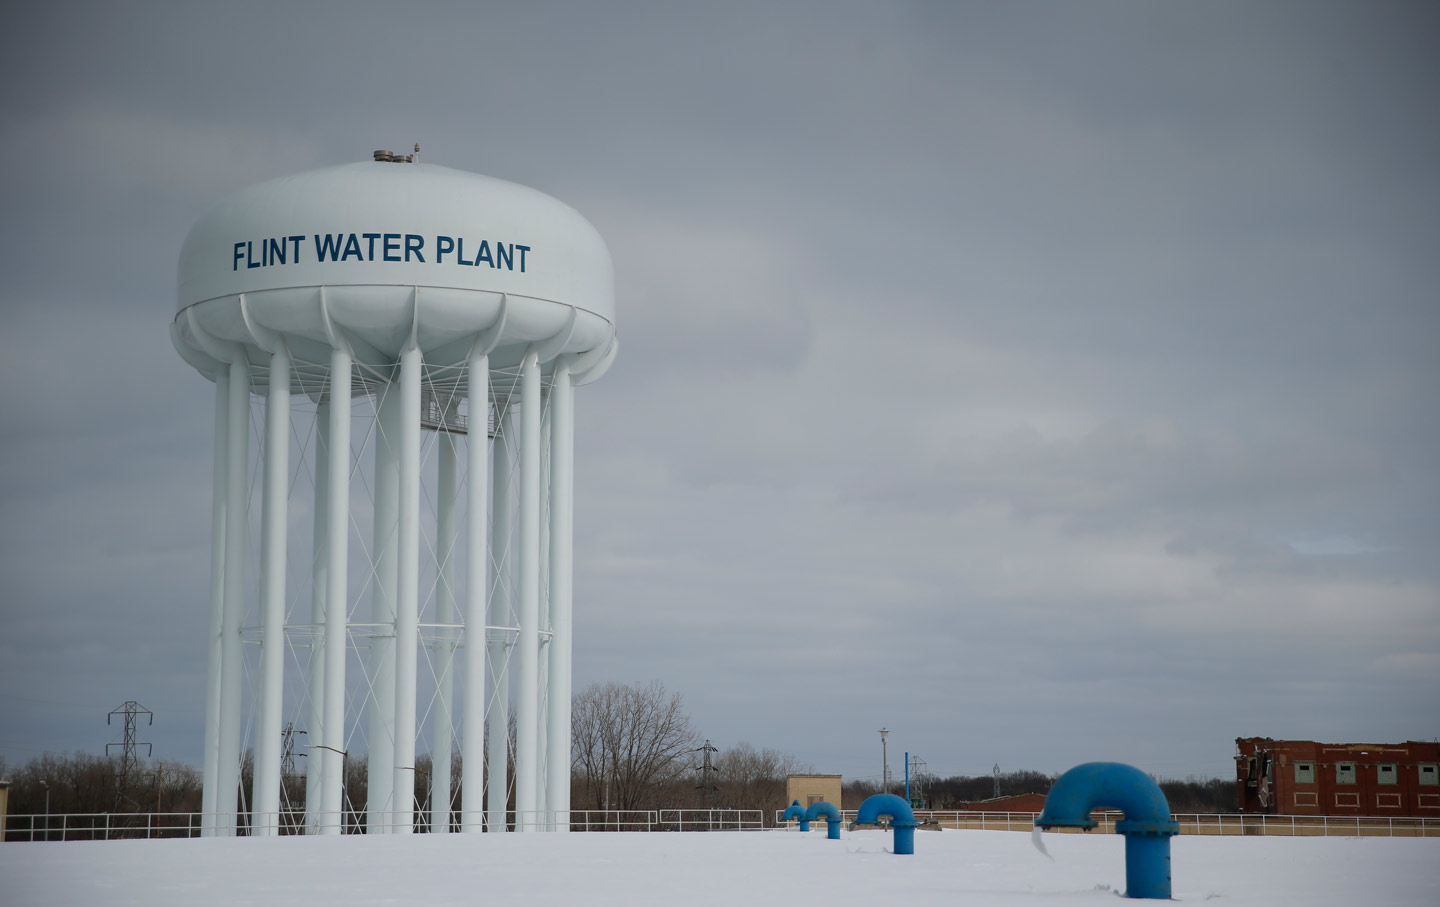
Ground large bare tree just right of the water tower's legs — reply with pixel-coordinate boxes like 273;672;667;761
572;681;700;809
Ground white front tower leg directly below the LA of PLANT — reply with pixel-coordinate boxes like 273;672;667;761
459;351;490;832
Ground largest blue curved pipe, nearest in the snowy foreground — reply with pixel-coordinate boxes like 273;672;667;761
1035;762;1179;900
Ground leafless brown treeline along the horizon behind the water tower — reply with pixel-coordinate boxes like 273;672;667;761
0;682;1236;826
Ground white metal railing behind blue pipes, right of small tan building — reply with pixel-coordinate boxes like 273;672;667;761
775;809;1440;838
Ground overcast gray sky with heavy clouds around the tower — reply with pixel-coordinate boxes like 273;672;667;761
0;1;1440;777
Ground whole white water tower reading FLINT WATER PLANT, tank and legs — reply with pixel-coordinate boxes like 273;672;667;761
170;153;618;835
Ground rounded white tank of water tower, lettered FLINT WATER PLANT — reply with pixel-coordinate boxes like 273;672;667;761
179;161;615;369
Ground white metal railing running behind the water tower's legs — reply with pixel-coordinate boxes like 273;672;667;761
0;809;765;841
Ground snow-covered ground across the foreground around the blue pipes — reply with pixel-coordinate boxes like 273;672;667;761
0;822;1440;907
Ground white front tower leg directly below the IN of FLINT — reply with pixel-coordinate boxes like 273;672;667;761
251;344;289;836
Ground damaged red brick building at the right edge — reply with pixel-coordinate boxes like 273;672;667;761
1236;737;1440;818
